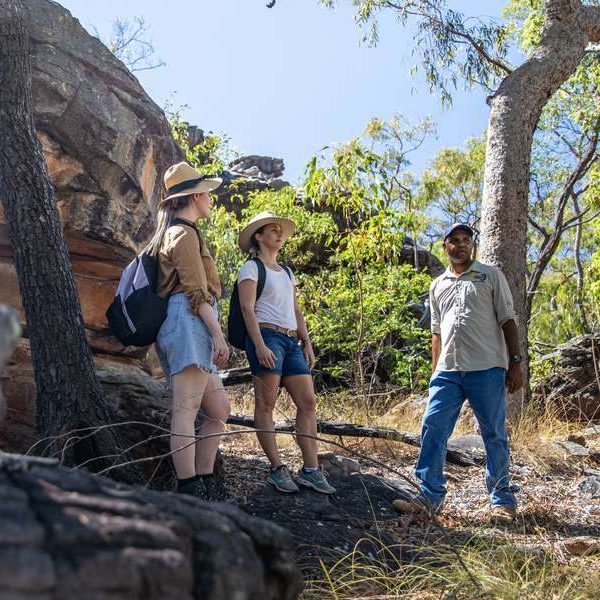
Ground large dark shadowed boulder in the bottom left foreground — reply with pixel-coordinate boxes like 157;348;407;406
0;452;302;600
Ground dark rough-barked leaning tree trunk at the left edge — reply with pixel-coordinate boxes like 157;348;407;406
0;0;138;478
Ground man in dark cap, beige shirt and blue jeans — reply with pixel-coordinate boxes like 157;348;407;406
394;223;523;523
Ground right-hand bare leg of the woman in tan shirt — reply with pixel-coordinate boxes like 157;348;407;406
196;375;229;475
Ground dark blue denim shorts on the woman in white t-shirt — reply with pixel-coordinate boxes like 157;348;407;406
246;328;310;377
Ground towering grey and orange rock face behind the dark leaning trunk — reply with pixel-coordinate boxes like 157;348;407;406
0;0;180;356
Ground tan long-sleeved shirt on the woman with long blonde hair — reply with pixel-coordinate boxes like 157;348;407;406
157;223;221;315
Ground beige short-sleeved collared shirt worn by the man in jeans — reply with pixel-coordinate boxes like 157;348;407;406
429;261;516;371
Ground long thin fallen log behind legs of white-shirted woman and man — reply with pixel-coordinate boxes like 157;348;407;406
227;414;485;467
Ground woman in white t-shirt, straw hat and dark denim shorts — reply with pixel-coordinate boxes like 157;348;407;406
238;211;336;494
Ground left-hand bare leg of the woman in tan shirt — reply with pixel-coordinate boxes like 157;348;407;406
171;365;209;479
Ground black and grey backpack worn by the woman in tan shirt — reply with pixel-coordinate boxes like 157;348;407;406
106;219;202;346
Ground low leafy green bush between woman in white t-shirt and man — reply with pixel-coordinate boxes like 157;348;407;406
301;263;431;389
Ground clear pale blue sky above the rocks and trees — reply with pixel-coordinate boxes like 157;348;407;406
60;0;504;182
